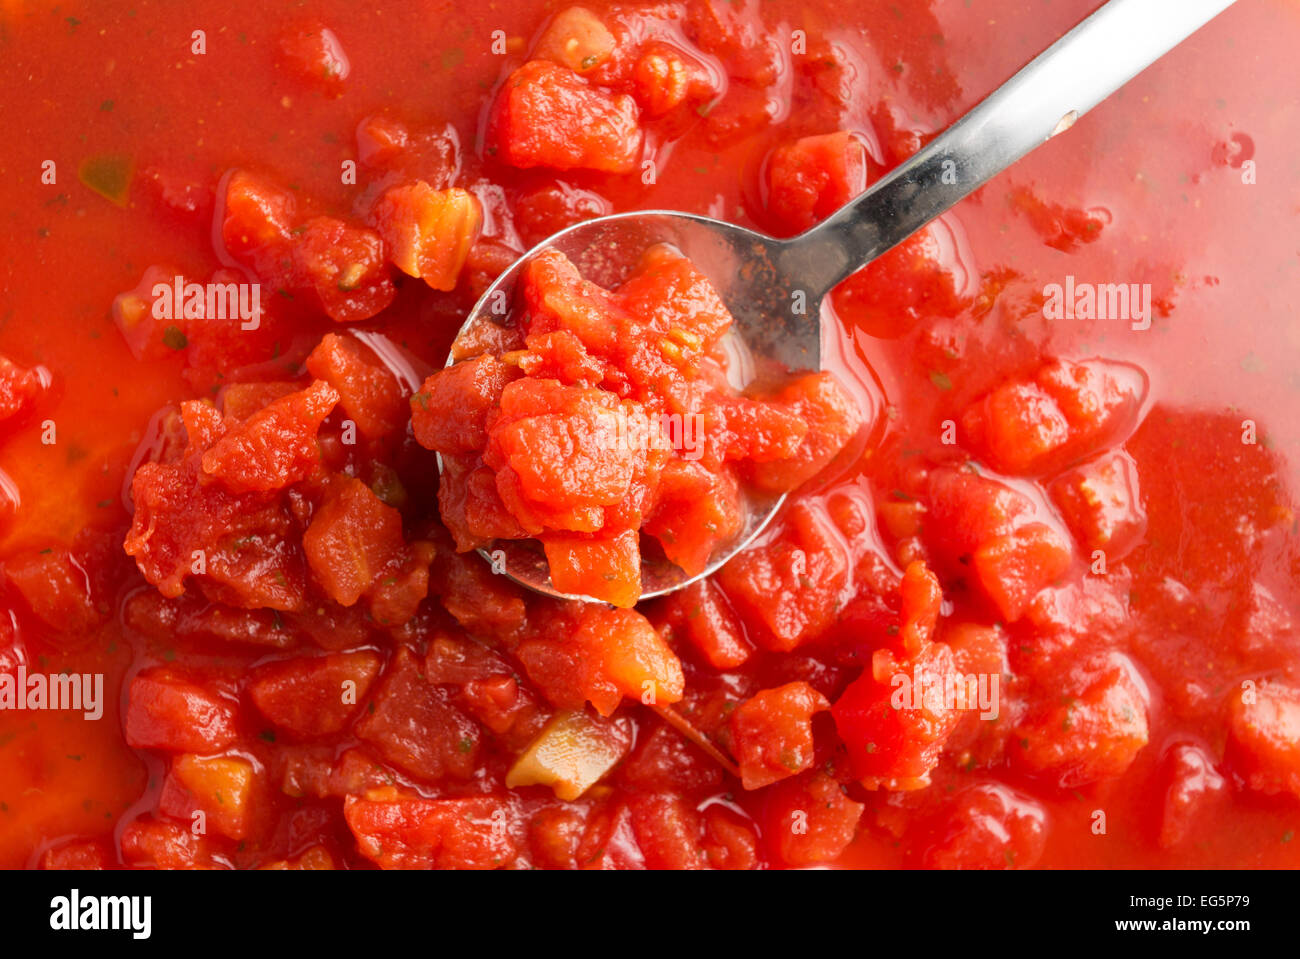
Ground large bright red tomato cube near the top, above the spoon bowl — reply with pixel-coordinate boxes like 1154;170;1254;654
489;60;641;173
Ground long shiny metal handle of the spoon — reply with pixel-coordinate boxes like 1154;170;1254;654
779;0;1235;301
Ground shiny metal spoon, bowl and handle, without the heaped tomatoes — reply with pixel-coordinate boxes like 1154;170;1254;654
439;0;1235;602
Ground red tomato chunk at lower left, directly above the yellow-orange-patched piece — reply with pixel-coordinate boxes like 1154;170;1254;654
125;669;238;754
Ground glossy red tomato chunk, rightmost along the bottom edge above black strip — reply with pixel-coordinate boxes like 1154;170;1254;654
922;782;1048;869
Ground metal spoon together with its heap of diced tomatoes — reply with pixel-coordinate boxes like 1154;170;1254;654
413;0;1234;607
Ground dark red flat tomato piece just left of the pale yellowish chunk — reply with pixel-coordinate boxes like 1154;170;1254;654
356;647;481;782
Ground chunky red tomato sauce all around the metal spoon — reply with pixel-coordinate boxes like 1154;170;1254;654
0;0;1300;868
